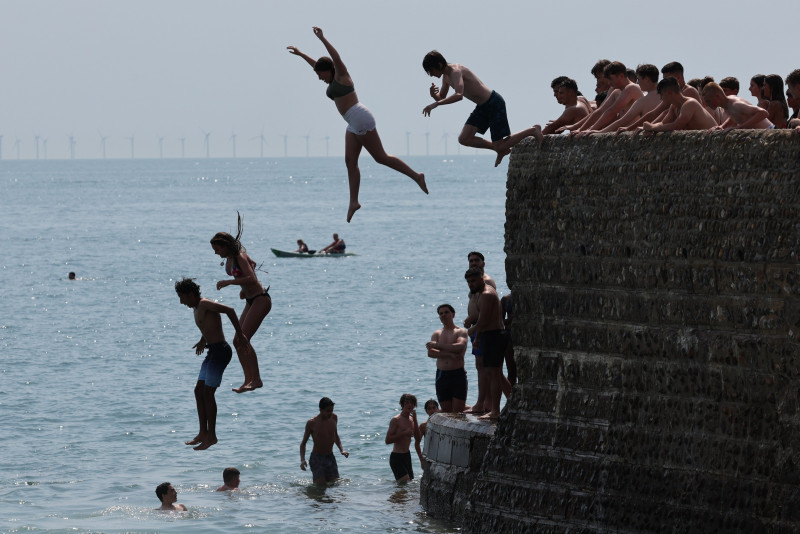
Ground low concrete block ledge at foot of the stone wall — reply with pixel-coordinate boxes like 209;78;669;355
420;413;495;523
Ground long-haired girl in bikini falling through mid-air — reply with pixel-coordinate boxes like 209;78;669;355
211;214;272;393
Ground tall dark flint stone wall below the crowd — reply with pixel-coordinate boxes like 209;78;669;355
464;131;800;533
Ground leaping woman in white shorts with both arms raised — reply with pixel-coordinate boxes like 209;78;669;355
286;26;428;222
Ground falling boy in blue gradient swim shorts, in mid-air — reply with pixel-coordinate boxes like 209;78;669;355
175;278;251;451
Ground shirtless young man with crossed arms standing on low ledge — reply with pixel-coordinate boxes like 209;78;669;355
425;304;467;412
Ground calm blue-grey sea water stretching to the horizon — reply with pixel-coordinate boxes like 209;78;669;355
0;156;507;533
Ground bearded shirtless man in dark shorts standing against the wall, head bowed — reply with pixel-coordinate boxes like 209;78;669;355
464;269;508;419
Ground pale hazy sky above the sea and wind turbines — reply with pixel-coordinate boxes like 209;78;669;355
0;0;800;160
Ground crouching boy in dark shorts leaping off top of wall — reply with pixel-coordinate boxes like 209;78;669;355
422;50;533;167
